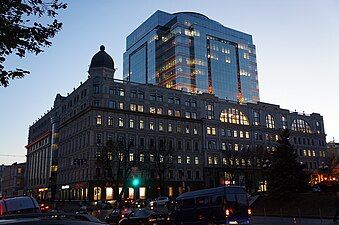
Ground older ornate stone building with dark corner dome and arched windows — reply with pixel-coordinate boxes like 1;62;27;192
27;46;326;201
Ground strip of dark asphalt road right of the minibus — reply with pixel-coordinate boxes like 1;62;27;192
251;216;339;225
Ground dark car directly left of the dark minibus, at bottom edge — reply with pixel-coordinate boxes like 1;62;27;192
119;209;171;225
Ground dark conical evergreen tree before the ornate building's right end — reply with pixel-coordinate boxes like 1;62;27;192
267;129;309;198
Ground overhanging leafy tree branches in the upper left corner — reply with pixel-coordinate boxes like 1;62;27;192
0;0;67;87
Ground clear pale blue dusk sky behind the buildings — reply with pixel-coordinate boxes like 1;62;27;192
0;0;339;164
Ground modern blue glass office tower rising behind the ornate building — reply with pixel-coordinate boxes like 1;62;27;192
123;11;259;102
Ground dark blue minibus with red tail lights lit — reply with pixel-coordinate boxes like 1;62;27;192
174;186;252;224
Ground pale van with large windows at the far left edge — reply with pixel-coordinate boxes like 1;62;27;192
0;196;40;216
